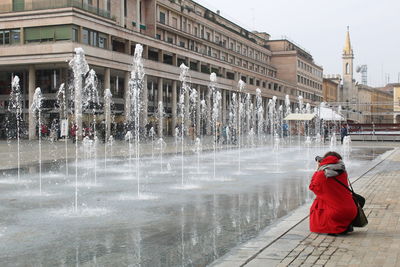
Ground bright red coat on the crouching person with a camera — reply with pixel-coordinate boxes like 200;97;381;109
309;156;357;234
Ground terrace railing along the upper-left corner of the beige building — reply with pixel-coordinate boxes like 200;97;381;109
0;0;115;20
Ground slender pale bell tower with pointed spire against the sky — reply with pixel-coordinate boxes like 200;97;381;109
340;26;357;103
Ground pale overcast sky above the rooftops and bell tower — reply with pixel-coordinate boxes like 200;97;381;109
195;0;400;86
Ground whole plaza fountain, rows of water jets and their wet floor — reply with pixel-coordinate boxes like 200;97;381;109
0;40;394;266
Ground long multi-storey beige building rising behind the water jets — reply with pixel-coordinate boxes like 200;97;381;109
0;0;322;138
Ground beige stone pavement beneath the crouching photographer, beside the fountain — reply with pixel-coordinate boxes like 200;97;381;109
212;143;400;267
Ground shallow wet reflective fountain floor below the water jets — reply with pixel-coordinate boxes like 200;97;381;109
0;148;388;266
